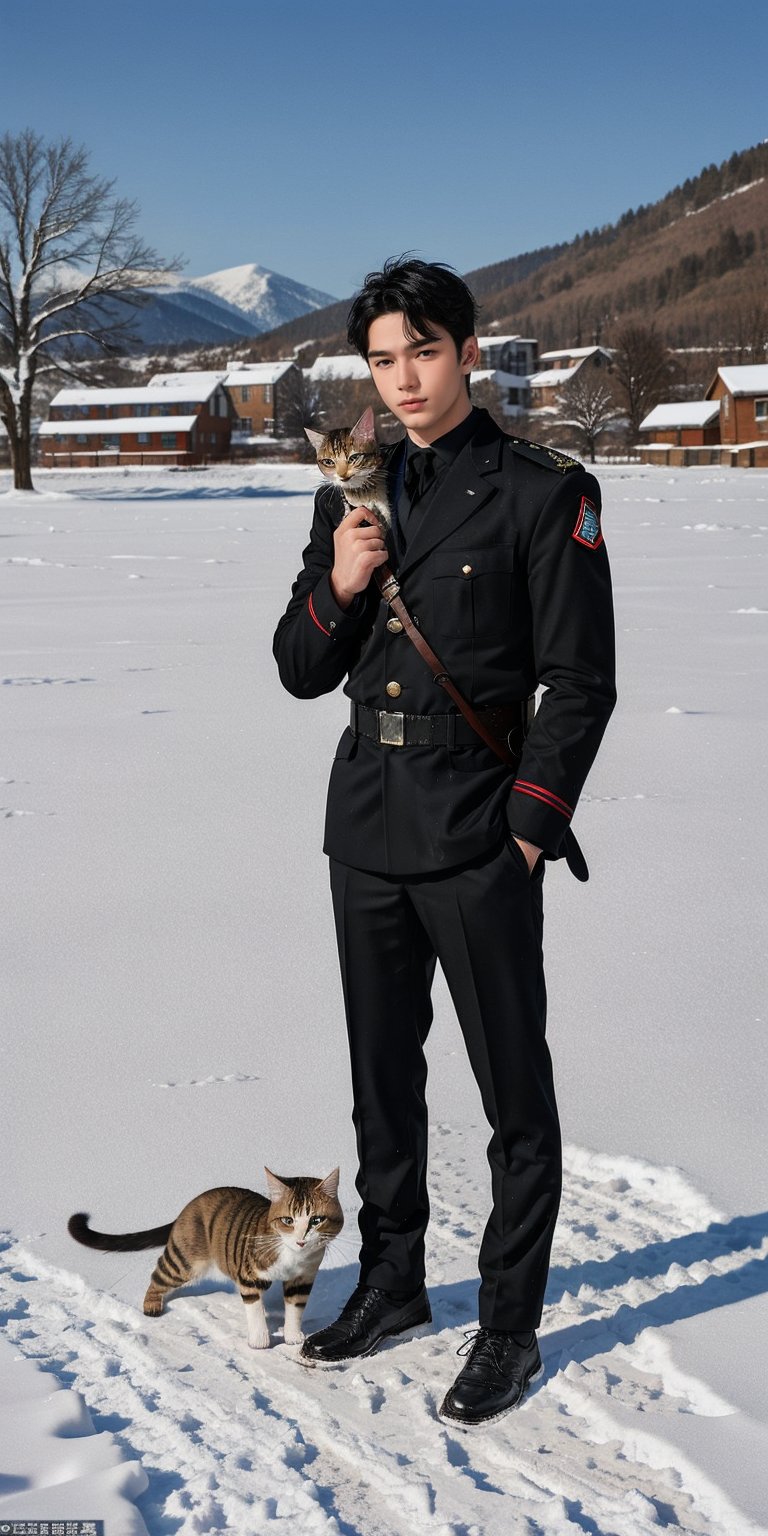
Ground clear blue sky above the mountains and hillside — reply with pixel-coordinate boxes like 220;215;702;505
0;0;768;296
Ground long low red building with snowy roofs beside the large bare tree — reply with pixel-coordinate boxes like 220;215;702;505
40;373;232;468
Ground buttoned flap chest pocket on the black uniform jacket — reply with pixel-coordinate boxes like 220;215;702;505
432;544;515;641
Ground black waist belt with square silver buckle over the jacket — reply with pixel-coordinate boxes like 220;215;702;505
349;694;536;751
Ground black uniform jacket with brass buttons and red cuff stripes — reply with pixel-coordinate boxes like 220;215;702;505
273;412;616;876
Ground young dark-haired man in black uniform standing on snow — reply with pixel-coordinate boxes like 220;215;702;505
275;260;616;1424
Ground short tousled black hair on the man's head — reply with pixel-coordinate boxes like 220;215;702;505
347;253;478;358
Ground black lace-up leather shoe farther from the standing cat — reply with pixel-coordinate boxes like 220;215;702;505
439;1329;544;1428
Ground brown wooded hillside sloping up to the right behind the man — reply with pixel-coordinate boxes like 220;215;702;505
255;141;768;356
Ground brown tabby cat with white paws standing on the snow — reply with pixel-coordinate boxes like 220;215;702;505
68;1167;344;1349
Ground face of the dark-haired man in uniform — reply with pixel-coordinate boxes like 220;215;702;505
369;310;478;445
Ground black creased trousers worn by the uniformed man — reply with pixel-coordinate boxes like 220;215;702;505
330;837;562;1330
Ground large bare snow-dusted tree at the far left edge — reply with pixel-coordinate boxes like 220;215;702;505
0;129;180;490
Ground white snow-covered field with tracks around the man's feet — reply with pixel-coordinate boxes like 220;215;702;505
0;465;768;1536
